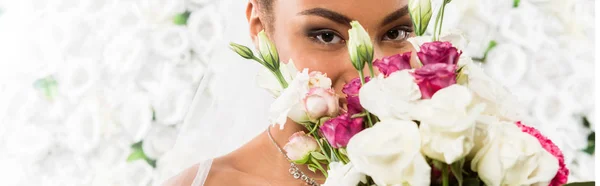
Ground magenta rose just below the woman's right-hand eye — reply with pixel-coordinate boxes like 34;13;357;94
373;52;411;77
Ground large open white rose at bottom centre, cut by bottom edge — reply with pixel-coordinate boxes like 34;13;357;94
347;119;431;186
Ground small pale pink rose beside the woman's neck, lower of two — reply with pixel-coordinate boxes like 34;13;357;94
283;131;319;164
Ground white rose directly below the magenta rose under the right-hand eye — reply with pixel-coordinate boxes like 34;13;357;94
359;70;421;120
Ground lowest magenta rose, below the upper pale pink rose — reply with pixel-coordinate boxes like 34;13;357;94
320;113;364;148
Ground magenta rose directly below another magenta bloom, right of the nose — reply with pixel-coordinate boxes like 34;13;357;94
412;63;457;99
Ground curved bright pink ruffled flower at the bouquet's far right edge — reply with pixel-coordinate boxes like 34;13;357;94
516;121;569;186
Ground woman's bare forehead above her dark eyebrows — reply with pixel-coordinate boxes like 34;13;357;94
276;0;408;26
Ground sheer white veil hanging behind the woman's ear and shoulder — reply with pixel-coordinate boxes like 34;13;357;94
158;0;273;180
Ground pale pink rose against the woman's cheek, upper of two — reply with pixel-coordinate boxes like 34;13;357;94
303;87;339;121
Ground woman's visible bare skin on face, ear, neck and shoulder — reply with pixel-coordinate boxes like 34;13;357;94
165;0;415;186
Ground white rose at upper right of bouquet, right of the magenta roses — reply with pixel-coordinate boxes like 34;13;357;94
459;61;523;121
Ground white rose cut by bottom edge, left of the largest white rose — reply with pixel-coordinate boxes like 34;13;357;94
323;162;367;186
